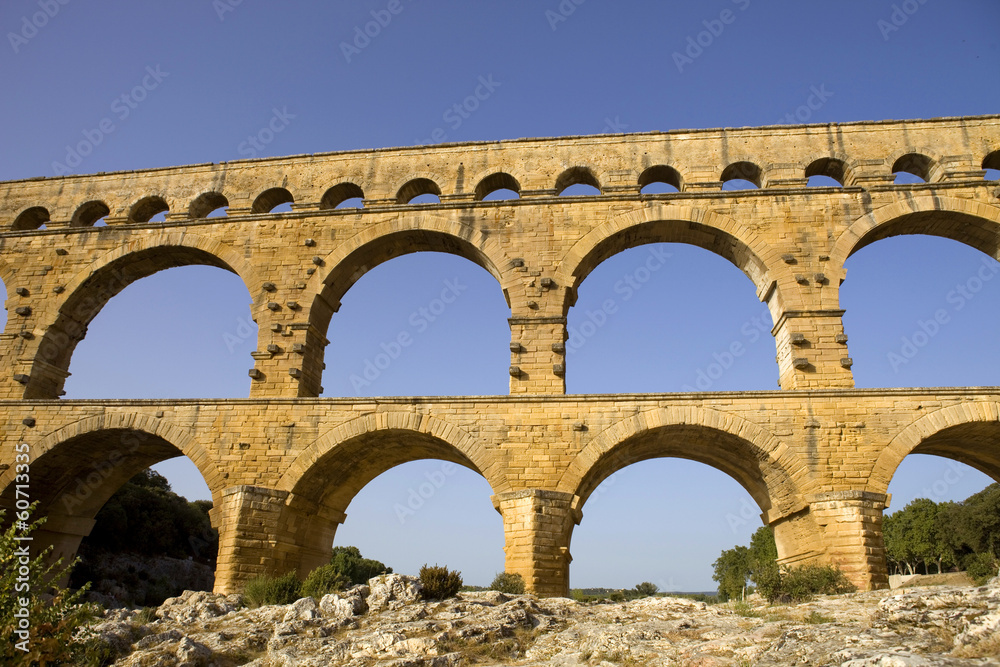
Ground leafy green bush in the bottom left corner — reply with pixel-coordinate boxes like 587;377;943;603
0;505;95;665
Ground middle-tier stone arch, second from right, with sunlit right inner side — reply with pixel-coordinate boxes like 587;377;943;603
556;202;796;316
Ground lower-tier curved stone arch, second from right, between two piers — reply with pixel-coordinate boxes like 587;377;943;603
557;406;807;521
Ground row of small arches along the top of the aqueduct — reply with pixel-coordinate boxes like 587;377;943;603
0;150;1000;231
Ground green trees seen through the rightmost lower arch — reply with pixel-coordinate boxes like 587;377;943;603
882;484;1000;584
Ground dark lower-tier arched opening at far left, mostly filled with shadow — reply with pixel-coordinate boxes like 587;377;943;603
2;428;218;606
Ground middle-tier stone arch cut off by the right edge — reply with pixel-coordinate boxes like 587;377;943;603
830;196;1000;267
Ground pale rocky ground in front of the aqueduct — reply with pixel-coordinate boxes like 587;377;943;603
86;575;1000;667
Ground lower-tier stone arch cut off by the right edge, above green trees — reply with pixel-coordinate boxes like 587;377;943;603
866;401;1000;494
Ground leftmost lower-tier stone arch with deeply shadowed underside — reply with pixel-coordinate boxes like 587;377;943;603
0;410;225;576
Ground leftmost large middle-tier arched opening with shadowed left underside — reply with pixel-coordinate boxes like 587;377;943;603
25;246;256;398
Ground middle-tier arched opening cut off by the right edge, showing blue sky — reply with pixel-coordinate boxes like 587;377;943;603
840;236;1000;387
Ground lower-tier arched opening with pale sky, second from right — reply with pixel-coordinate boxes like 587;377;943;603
570;424;796;592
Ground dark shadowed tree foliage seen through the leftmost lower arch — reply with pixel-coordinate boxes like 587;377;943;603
81;469;219;565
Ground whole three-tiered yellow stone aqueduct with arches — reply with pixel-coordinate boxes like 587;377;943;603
0;116;1000;595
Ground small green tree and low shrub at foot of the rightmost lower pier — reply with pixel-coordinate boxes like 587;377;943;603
712;526;855;602
